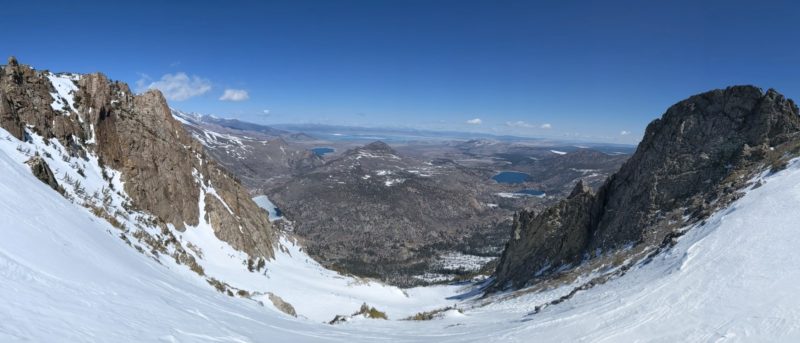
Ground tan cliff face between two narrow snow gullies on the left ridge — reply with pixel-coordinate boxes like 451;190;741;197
78;74;206;229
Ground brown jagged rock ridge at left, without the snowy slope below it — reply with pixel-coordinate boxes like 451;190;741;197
0;59;274;257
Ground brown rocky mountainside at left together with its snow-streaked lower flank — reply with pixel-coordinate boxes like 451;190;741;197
0;58;275;259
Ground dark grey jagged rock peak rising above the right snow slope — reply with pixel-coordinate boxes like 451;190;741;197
494;86;800;289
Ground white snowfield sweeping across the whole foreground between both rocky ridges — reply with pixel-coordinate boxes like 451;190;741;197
0;118;800;342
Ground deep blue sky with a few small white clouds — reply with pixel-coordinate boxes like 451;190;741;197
0;0;800;143
